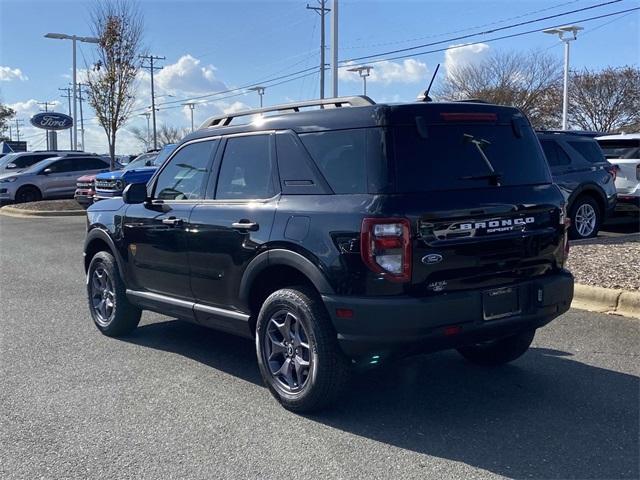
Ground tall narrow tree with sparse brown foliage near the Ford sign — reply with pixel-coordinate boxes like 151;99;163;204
87;0;143;169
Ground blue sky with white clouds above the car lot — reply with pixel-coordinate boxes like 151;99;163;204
0;0;640;153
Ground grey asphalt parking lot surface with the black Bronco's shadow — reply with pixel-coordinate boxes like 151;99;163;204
0;217;640;479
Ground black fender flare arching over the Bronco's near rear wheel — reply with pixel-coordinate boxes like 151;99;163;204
239;248;335;304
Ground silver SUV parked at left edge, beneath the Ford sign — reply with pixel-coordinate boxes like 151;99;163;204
0;155;109;203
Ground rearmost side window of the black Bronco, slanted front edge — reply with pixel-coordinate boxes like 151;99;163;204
300;129;368;193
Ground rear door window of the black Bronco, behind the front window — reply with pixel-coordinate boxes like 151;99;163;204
216;135;275;199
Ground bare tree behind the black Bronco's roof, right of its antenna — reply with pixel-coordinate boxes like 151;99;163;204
437;51;562;128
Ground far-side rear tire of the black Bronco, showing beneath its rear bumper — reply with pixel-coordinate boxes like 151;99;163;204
458;330;536;367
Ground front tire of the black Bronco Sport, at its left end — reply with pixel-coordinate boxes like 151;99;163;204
87;252;142;337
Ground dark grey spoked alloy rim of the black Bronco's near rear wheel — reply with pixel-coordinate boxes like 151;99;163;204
263;310;312;393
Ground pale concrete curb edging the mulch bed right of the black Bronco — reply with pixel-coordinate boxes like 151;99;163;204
571;283;640;319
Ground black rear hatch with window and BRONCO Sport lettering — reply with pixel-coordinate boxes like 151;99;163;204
364;104;566;296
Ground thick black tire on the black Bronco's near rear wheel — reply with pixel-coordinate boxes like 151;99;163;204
256;286;351;413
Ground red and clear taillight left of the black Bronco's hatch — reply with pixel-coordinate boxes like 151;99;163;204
360;218;411;282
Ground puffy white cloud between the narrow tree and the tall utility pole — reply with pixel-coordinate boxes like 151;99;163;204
154;55;226;95
